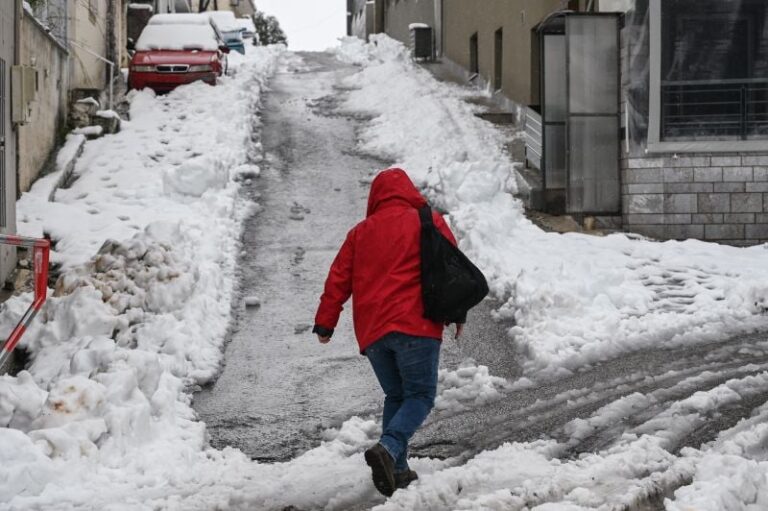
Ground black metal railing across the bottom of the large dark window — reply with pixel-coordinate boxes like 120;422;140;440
661;79;768;140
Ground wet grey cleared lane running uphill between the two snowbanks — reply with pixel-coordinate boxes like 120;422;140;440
195;53;517;461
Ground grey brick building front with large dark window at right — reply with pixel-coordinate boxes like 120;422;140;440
622;0;768;245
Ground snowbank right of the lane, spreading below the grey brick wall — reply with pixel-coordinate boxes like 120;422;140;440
337;35;768;379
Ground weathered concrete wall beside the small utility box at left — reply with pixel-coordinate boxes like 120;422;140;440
18;11;69;192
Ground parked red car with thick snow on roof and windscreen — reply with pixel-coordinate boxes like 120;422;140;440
128;14;229;92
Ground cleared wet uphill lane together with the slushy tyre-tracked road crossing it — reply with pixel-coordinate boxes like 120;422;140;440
195;49;768;509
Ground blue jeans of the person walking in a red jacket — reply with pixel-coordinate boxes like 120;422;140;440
365;333;440;472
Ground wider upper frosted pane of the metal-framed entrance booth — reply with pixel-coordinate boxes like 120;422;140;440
566;16;619;114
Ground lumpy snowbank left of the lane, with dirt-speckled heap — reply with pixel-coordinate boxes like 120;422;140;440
0;46;283;509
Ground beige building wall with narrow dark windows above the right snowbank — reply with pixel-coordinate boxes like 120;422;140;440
442;0;563;105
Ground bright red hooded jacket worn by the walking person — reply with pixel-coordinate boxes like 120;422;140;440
315;168;456;353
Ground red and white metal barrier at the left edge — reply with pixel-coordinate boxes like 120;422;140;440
0;234;51;366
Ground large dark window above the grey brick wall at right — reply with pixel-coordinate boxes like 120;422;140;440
660;0;768;142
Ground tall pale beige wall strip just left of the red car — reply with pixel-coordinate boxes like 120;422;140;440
69;0;109;90
